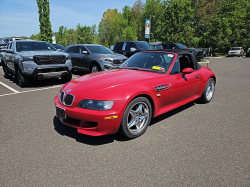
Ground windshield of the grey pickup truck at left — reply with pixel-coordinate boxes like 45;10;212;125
16;42;55;52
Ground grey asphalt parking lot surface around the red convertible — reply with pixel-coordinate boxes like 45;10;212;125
0;57;250;187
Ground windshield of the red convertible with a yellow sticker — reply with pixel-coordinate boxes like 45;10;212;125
120;52;175;73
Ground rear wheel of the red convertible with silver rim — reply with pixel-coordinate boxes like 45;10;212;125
200;78;215;103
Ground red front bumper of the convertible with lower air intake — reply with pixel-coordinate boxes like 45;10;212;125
55;94;126;136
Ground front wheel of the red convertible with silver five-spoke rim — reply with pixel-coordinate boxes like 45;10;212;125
119;97;152;139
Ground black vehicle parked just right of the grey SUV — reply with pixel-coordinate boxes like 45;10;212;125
113;41;154;57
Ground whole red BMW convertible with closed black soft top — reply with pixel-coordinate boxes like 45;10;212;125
55;49;216;138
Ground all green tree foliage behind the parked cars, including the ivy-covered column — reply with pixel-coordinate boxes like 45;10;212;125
30;0;250;53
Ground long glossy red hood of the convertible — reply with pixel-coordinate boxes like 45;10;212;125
62;69;163;102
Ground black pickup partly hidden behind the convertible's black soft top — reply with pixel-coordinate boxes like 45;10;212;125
158;42;204;61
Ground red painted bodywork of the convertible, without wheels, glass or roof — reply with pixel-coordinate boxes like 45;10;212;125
55;51;215;136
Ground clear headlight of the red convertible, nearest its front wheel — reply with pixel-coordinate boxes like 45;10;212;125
77;99;114;110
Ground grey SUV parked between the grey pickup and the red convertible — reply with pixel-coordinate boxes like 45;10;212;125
64;44;127;73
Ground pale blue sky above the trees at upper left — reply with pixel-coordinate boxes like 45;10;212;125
0;0;144;38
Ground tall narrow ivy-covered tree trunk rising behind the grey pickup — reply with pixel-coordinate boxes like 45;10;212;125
36;0;52;43
